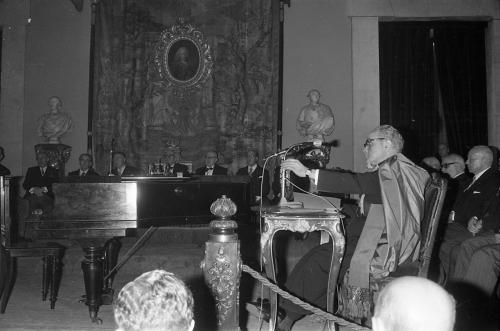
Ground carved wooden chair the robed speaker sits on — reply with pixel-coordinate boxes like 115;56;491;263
339;177;448;324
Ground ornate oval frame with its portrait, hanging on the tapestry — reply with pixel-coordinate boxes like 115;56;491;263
155;19;213;94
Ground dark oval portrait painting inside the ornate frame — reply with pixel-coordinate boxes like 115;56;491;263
167;39;200;81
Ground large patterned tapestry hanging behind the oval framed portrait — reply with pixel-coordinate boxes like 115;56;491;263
92;0;279;173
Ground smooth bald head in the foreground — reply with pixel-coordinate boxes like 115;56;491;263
372;276;455;331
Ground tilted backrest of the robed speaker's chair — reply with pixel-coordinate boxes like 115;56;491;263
418;176;448;278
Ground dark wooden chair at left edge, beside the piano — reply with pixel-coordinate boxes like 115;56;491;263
0;176;65;314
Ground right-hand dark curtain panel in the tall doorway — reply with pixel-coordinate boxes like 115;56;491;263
435;22;488;155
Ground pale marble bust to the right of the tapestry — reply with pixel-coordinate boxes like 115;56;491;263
296;90;335;141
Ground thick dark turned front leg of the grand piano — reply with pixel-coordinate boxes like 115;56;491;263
82;243;104;324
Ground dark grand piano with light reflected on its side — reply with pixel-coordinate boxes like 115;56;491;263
25;176;251;323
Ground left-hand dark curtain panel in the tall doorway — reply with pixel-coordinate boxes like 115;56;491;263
379;22;439;162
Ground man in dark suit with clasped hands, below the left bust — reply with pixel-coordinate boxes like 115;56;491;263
23;152;59;213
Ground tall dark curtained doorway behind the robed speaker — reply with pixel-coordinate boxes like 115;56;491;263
379;21;488;161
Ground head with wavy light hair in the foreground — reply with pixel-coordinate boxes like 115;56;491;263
113;270;194;331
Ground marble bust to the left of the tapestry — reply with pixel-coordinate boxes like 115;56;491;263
38;96;72;144
